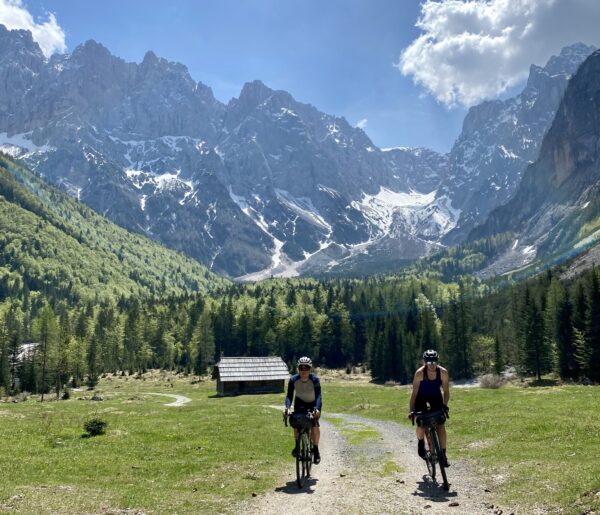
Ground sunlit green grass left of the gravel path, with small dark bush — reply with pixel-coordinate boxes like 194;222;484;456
0;377;292;513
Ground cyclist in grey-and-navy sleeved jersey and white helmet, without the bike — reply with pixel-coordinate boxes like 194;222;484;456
283;356;322;465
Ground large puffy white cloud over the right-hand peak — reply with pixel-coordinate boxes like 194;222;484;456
397;0;600;106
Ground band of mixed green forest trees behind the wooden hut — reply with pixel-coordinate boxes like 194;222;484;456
0;260;600;396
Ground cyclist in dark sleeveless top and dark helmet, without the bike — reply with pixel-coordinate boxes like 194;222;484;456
408;349;450;467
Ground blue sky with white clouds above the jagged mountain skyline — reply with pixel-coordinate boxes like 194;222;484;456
0;0;600;152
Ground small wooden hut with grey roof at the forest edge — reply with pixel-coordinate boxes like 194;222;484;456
212;356;290;395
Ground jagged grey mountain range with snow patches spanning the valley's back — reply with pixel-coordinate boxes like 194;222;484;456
0;26;594;279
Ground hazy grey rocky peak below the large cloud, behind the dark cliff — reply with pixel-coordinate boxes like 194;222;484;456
442;44;594;243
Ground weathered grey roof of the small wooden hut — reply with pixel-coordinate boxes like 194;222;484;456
213;356;290;382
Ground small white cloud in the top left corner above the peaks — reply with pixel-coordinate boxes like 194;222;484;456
0;0;66;57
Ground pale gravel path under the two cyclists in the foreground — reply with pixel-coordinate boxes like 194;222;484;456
241;414;512;515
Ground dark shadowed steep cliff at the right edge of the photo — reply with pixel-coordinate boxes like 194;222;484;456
469;51;600;278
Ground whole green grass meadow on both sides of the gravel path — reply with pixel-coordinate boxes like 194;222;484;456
0;372;600;514
